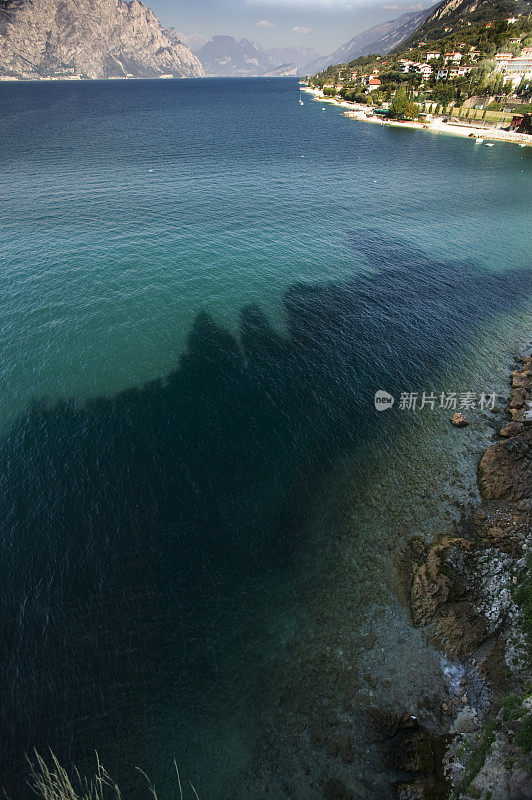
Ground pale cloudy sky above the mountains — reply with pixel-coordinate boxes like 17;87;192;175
148;0;435;55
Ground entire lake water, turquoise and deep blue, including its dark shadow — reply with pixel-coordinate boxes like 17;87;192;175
0;79;532;800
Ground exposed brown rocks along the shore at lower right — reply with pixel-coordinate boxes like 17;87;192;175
386;356;532;800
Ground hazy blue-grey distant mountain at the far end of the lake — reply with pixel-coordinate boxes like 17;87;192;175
196;36;308;78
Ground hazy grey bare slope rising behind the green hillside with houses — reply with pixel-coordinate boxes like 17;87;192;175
305;0;438;74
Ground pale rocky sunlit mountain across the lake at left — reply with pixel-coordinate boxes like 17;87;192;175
0;0;204;79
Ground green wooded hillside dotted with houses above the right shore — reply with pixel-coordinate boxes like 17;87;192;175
310;0;532;95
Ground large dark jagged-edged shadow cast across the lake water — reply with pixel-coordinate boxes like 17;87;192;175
0;231;526;800
